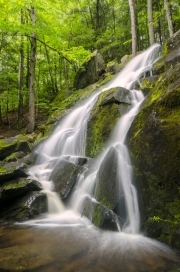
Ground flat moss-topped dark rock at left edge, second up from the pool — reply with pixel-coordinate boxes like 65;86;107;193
0;179;42;203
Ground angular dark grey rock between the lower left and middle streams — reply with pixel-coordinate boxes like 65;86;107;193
49;159;82;199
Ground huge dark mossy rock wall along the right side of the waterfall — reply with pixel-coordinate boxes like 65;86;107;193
127;60;180;250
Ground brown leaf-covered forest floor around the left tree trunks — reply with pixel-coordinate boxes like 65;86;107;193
0;108;47;138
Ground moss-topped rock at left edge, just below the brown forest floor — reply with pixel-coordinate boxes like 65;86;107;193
0;135;31;160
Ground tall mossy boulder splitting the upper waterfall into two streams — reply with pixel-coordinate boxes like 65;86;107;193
86;87;128;157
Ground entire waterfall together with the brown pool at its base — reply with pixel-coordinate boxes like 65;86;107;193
0;45;180;272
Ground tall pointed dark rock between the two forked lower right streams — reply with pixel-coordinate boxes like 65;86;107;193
95;147;122;210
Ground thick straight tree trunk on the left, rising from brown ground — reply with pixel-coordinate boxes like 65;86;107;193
27;7;36;133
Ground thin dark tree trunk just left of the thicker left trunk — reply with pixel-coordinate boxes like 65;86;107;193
18;9;24;128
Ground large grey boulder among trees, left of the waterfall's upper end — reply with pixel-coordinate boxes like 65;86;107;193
74;51;105;89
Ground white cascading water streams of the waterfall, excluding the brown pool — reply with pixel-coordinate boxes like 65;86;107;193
29;45;159;233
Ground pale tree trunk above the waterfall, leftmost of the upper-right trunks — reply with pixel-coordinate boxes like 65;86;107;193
128;0;137;57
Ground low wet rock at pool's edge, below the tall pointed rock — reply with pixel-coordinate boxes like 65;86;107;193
82;198;119;231
